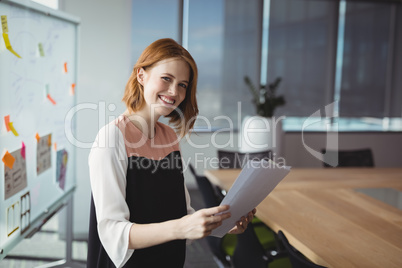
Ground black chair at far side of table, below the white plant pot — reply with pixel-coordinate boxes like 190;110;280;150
218;150;272;169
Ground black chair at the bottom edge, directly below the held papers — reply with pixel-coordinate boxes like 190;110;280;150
233;223;291;268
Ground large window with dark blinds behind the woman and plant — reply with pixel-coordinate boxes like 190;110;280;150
133;0;402;130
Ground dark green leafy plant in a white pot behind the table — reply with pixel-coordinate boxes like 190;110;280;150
239;76;286;154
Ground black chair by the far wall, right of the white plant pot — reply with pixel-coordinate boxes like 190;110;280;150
321;149;374;167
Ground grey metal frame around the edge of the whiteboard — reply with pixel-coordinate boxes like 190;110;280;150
0;0;81;261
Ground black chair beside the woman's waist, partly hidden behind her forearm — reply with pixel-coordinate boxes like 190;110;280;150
189;164;237;267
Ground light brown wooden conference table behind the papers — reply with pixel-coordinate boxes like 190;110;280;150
205;168;402;268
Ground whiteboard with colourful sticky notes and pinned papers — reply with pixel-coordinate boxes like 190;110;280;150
0;0;79;260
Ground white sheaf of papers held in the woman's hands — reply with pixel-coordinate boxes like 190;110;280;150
211;160;290;237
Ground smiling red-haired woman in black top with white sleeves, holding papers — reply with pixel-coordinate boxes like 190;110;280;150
87;39;255;268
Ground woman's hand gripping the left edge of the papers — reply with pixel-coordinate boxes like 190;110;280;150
176;205;230;239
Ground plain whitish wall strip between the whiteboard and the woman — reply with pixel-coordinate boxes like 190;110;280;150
60;0;132;239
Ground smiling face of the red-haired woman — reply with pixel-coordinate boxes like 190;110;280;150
137;58;190;116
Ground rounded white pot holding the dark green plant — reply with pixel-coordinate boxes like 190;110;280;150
239;115;283;156
